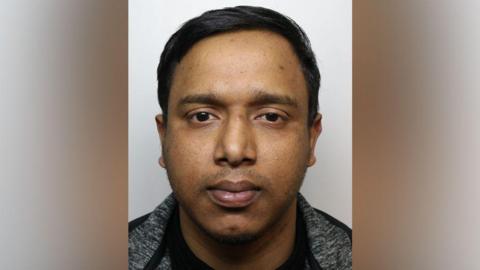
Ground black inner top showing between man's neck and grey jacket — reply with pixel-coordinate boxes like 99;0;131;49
165;207;308;270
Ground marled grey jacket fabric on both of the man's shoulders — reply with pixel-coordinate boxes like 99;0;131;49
128;193;352;270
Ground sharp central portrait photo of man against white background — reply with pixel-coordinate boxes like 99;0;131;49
128;1;352;269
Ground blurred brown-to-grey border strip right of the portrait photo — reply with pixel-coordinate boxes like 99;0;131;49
353;1;480;270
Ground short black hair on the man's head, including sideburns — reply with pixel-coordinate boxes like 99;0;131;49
157;6;320;125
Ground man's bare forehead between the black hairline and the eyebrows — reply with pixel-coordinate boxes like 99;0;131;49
170;30;308;105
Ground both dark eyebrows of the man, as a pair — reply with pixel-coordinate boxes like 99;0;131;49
178;90;298;108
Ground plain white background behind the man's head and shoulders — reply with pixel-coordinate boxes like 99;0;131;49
128;0;352;226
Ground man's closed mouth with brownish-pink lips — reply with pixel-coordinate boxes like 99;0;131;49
207;180;261;209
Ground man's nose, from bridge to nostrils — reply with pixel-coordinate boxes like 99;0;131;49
215;116;257;167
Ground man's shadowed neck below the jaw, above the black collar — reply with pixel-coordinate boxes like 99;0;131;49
180;199;297;269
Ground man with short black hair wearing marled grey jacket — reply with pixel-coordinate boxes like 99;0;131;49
129;6;351;269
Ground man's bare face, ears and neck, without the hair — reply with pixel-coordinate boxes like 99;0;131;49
156;30;321;269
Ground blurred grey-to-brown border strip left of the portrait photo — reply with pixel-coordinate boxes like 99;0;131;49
0;0;128;269
